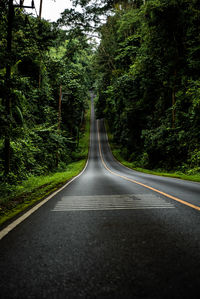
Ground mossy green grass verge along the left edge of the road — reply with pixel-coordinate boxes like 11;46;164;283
0;103;90;226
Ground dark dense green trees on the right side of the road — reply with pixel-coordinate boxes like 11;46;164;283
95;0;200;172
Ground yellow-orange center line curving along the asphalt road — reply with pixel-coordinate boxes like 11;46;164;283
97;121;200;211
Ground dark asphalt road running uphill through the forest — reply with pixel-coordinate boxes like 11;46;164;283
0;98;200;299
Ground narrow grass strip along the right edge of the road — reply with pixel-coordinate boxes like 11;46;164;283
105;122;200;182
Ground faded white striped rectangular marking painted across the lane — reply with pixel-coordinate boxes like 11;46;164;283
52;194;174;212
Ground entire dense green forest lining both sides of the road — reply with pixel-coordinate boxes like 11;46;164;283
0;0;200;218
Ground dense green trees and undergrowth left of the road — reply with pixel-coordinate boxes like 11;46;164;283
0;0;92;188
